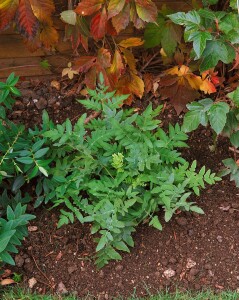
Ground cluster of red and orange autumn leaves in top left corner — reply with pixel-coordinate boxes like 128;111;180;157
0;0;58;51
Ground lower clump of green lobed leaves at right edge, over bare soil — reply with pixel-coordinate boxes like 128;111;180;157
183;88;239;187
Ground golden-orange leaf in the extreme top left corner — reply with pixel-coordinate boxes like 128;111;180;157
0;0;19;30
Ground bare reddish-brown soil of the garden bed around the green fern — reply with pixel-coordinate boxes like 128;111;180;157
6;81;239;299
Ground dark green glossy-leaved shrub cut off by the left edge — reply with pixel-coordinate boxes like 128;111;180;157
0;73;38;264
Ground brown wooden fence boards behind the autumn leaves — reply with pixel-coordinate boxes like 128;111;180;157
0;0;189;78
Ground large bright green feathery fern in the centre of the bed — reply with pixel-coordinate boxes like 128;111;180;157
35;76;220;267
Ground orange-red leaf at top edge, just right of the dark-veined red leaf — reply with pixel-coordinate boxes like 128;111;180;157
29;0;55;22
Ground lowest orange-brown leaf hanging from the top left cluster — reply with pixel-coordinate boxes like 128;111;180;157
40;23;58;50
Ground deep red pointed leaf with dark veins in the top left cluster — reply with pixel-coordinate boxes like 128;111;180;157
16;0;39;38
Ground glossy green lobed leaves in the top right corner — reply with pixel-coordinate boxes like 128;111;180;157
168;1;239;72
